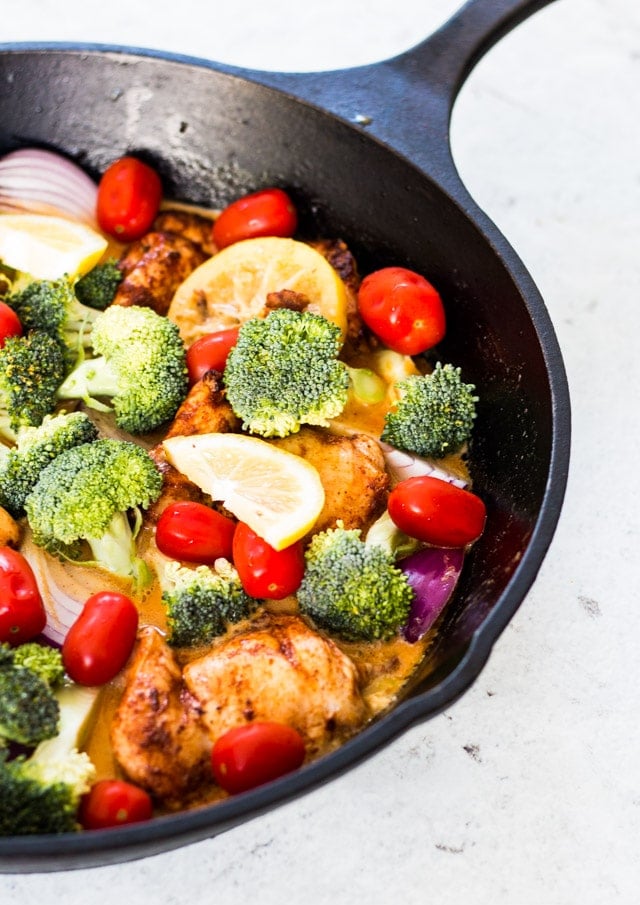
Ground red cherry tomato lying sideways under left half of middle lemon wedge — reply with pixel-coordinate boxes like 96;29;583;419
156;500;236;565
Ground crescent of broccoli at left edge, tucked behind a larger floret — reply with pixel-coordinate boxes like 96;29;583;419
0;412;98;518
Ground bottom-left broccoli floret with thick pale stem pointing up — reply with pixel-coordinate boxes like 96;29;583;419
0;685;96;836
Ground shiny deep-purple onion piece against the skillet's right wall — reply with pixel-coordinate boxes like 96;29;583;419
398;547;464;644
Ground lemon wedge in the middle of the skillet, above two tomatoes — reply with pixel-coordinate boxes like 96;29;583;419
162;434;324;550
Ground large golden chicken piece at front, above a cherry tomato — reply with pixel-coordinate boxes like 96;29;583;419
183;614;367;755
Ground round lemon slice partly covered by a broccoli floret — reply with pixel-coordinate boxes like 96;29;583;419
168;236;347;345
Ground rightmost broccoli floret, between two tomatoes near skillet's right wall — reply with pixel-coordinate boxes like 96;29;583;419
381;362;478;459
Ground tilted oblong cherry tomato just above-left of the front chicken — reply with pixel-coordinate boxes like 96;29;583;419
62;591;138;685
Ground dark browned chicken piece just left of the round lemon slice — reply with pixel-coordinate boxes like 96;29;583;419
113;232;207;314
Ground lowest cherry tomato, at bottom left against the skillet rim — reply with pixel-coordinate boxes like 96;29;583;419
79;779;153;830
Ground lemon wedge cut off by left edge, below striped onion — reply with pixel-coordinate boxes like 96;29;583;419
0;214;108;280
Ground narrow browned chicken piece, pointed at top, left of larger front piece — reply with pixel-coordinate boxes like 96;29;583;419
111;626;211;810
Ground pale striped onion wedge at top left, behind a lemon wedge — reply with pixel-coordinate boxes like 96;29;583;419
0;148;98;229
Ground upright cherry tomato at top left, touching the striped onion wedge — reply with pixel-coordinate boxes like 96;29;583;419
97;157;162;242
